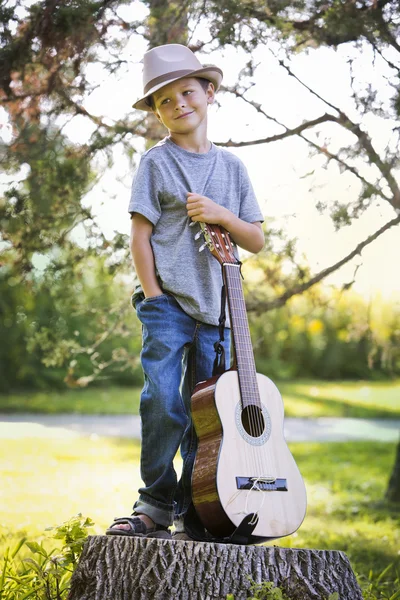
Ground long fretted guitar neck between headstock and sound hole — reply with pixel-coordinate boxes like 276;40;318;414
222;263;261;408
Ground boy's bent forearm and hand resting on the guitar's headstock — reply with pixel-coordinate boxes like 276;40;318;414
186;192;265;254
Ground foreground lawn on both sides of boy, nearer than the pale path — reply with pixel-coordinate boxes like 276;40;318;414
0;433;400;598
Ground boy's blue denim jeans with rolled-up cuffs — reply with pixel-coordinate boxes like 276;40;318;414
133;294;230;526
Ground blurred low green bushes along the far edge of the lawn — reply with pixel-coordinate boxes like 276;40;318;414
0;255;400;391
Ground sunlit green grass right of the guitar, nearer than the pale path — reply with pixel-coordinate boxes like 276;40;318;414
279;442;400;576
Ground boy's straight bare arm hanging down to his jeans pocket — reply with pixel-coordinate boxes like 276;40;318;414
130;213;163;298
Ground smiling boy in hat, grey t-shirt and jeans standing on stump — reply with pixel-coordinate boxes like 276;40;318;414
107;44;264;539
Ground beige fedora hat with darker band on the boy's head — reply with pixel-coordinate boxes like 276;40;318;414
132;44;223;111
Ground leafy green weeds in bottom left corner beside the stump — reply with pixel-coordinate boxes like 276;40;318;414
0;514;94;600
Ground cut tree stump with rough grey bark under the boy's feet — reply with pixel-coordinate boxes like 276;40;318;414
69;536;362;600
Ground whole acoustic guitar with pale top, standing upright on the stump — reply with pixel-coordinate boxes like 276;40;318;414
192;223;307;543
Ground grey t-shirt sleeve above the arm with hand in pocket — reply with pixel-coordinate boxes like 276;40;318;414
128;156;163;225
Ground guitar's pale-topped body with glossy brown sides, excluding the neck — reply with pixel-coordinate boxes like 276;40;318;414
192;371;307;542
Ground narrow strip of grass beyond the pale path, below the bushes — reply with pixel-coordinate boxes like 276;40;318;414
0;380;400;419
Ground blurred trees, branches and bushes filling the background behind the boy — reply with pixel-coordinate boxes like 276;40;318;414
0;0;400;392
